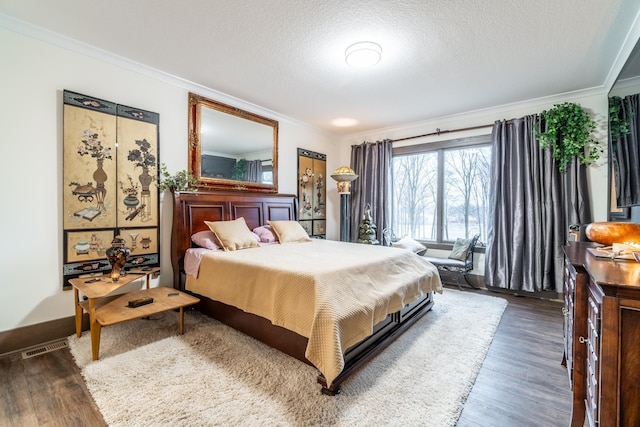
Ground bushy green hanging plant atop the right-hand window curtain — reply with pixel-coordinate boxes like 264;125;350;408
536;102;602;172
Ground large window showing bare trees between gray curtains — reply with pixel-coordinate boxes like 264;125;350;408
392;135;491;242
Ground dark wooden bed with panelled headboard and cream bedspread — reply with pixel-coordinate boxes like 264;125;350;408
171;192;442;395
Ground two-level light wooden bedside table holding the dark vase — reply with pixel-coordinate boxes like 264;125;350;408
69;267;200;360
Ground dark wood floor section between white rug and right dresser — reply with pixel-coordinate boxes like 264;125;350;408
457;291;571;427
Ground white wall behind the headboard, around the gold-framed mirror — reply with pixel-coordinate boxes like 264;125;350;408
0;28;340;331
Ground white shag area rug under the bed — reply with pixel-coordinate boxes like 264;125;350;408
68;289;507;427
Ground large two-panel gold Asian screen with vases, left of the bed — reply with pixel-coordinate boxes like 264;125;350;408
62;90;160;289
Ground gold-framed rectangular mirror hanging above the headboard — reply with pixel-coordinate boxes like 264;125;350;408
189;93;278;193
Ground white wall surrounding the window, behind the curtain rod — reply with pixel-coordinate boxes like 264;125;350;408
340;91;608;274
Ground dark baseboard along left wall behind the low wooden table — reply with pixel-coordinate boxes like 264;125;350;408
0;313;89;357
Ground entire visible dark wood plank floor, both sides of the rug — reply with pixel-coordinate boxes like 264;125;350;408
0;291;571;427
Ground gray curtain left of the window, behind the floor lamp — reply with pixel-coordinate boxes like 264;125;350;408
350;139;393;244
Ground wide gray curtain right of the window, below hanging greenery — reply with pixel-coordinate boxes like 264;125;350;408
484;115;591;292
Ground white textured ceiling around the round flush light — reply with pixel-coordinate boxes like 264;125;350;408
0;0;640;134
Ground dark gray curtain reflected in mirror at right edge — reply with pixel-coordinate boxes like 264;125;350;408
611;94;640;207
